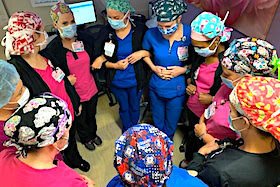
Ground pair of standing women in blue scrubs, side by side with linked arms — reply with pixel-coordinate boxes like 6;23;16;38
92;0;191;139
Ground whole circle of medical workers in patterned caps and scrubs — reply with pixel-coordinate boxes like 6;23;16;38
0;0;280;187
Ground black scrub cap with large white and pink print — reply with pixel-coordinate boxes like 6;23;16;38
4;93;72;156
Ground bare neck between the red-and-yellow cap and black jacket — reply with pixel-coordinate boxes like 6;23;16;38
240;127;276;154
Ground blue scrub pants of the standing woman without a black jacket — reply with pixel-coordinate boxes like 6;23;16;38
150;90;185;139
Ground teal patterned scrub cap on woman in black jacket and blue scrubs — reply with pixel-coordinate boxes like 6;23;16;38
106;0;135;13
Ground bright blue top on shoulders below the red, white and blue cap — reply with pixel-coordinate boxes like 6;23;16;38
107;166;207;187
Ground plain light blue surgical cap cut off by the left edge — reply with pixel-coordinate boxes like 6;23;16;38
0;59;20;108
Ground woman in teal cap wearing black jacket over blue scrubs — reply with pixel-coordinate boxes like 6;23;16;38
92;0;149;132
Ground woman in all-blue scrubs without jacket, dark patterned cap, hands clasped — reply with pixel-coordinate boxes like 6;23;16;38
143;0;191;139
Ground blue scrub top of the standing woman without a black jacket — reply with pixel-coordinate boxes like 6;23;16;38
143;24;191;98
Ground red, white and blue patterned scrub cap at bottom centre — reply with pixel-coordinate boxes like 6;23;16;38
114;124;174;187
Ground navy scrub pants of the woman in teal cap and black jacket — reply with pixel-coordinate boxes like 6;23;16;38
111;86;142;132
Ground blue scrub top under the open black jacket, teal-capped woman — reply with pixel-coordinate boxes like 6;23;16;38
112;30;137;88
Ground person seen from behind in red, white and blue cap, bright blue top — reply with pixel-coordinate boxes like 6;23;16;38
107;124;207;187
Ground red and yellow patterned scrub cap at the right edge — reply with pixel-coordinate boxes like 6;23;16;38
229;76;280;141
